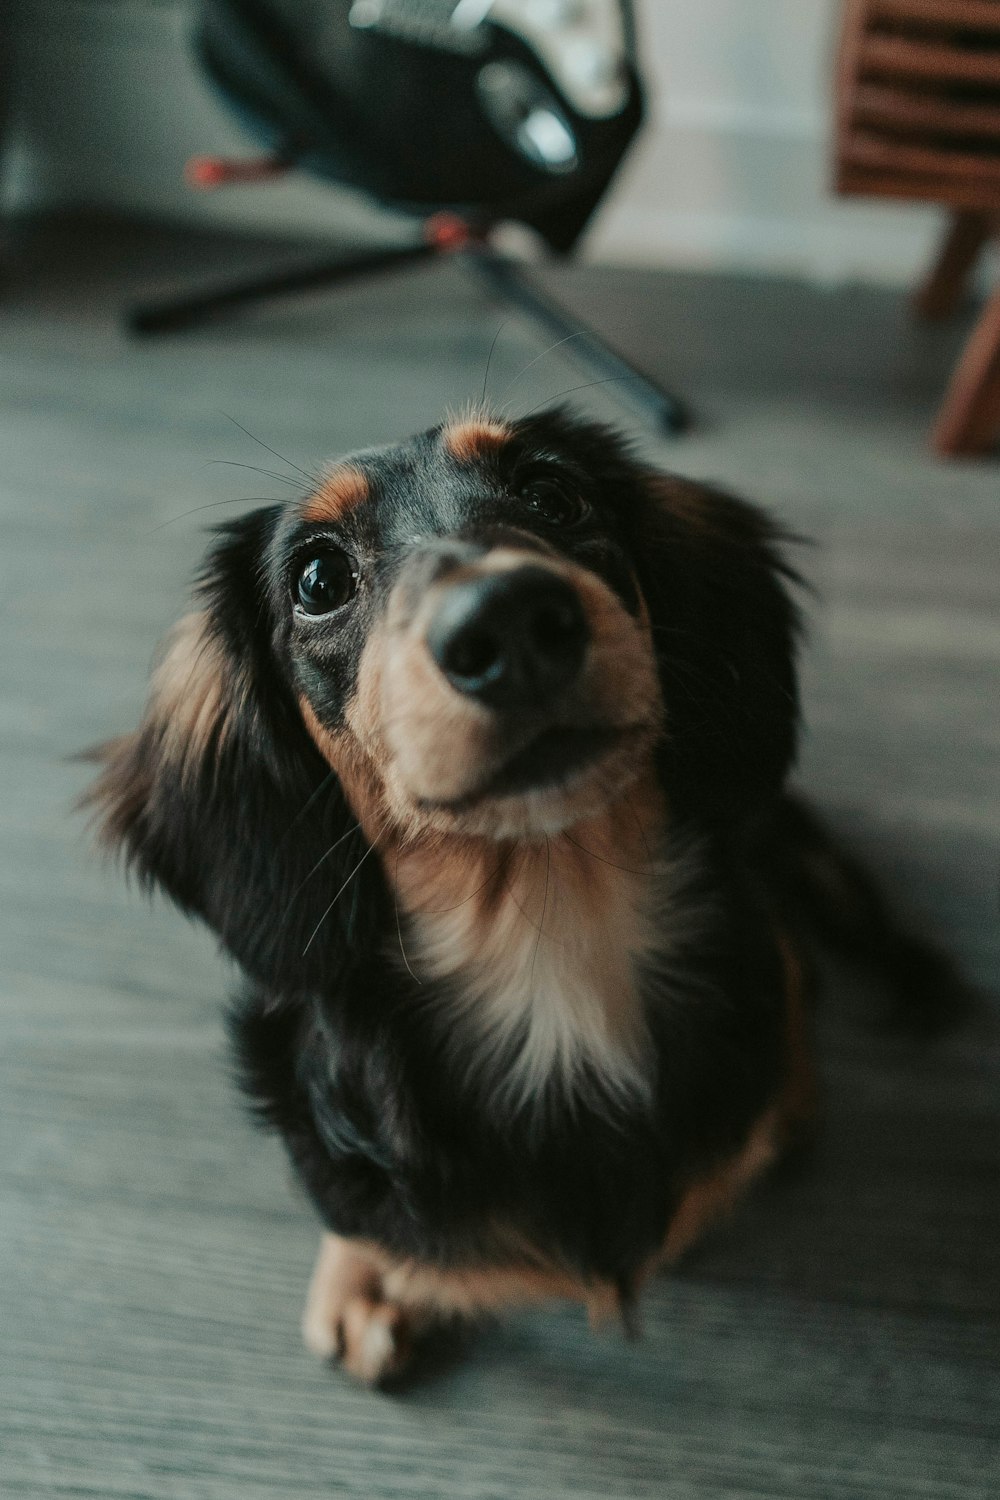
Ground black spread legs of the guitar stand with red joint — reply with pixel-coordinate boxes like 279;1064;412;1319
127;213;688;432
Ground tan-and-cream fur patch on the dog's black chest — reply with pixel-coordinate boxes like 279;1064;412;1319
386;806;683;1112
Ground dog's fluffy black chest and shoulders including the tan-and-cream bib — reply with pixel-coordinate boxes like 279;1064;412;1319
234;809;781;1286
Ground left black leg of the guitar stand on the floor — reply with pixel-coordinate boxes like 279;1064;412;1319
126;240;439;335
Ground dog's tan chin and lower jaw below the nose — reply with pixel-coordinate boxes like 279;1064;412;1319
398;725;654;840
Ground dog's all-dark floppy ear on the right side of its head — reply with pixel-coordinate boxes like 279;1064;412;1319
628;473;798;828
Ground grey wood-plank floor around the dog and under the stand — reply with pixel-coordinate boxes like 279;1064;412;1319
0;221;1000;1500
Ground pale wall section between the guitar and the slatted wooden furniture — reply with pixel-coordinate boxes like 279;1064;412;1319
592;0;940;284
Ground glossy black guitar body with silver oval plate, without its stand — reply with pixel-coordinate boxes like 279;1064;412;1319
196;0;642;251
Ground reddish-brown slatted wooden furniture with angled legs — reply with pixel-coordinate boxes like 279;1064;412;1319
837;0;1000;453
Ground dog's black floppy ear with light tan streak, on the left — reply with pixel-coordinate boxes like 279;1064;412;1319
84;507;381;989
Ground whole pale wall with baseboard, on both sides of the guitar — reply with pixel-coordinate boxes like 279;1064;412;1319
0;0;959;284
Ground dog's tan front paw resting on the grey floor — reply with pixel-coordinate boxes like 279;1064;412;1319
301;1233;414;1385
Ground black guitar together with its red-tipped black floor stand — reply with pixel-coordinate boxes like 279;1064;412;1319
117;0;685;432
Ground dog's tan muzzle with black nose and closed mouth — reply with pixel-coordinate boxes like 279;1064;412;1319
364;534;658;839
